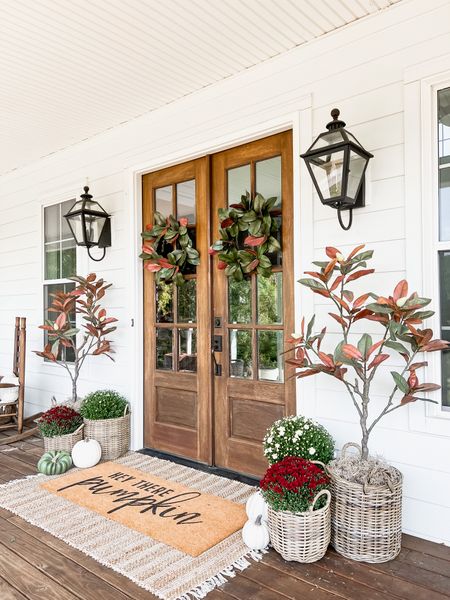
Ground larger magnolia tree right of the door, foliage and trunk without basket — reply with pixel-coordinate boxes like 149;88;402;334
287;244;449;461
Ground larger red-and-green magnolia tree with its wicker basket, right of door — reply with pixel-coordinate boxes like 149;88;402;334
287;245;449;562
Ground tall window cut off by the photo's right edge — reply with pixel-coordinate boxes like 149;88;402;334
437;87;450;409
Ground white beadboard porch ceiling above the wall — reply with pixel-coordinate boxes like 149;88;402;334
0;0;400;174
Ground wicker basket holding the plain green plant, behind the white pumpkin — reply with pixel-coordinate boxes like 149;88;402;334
84;405;130;460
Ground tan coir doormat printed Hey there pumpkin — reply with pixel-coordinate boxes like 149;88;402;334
41;462;247;556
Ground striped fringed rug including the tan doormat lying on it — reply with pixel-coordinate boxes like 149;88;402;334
0;453;261;600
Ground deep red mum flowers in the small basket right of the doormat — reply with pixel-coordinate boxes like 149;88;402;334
259;456;329;513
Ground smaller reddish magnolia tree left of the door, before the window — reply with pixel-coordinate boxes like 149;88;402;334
35;273;117;403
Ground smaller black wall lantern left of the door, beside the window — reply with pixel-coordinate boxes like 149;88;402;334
64;186;111;262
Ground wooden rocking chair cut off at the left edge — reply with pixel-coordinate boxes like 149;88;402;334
0;317;36;444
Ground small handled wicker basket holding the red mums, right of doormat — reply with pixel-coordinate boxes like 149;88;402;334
268;490;331;563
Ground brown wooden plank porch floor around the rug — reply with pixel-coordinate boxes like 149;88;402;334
0;432;450;600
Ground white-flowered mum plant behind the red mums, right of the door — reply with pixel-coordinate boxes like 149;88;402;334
263;416;334;465
